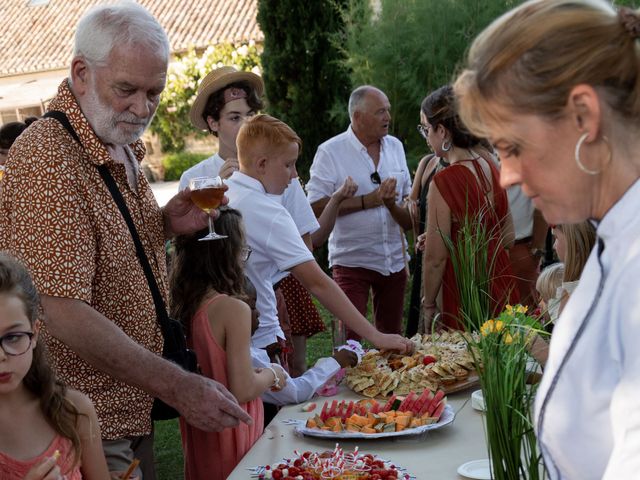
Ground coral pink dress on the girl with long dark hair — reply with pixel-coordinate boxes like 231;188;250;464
180;295;264;480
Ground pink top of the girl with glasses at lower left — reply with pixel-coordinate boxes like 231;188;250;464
0;435;82;480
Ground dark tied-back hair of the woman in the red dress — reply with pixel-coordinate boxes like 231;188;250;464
420;85;492;151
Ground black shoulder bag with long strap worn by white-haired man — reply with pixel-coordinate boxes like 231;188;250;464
44;111;198;420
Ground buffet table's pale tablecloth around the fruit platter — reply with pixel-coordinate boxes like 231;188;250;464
228;387;487;480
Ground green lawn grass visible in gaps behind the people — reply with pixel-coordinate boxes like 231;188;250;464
155;283;411;480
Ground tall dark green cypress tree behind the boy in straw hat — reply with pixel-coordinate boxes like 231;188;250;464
258;0;350;178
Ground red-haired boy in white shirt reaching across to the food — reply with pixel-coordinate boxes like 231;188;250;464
227;115;413;351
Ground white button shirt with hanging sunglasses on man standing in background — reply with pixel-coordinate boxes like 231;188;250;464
307;127;411;275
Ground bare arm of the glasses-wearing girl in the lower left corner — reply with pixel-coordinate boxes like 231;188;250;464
67;390;111;480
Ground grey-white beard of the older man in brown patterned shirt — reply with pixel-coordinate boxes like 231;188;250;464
83;81;155;145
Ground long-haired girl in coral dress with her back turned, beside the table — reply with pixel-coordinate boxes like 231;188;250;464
170;208;285;480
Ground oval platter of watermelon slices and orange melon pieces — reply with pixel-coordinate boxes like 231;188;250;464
287;390;455;439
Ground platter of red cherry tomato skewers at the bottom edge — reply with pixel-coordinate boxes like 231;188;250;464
251;445;415;480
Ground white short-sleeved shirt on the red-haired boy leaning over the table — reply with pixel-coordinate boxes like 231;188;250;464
226;172;314;348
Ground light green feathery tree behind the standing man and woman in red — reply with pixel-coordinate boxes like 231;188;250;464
334;0;520;169
